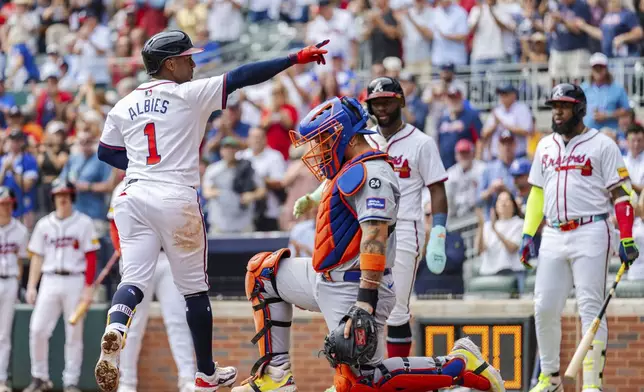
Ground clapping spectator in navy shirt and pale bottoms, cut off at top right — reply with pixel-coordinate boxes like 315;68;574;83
544;0;591;79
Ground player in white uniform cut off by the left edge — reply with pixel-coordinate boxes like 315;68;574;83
0;186;29;392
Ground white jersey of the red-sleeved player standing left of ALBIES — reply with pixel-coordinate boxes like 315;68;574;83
28;211;100;273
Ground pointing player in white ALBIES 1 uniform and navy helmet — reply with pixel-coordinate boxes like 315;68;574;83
95;30;328;392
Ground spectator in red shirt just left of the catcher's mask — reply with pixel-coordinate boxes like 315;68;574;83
261;83;297;160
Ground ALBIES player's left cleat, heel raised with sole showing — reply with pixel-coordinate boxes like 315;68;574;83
94;329;123;392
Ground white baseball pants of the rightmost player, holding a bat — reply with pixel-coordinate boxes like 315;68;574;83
534;221;612;379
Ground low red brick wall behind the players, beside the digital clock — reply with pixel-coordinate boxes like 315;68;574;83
139;306;644;392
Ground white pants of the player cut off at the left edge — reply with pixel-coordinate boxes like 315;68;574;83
0;277;18;383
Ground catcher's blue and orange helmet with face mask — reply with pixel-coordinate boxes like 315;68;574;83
290;97;376;181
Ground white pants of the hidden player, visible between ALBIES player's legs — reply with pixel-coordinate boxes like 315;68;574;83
120;252;195;389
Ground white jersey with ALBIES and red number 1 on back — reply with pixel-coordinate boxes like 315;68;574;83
101;75;226;187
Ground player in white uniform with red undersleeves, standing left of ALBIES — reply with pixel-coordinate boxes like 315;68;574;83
25;179;100;392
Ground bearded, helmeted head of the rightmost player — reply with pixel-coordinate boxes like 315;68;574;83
546;83;587;135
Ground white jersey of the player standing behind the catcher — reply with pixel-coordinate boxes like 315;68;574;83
366;124;447;221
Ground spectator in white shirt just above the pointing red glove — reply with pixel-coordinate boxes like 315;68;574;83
306;0;359;70
